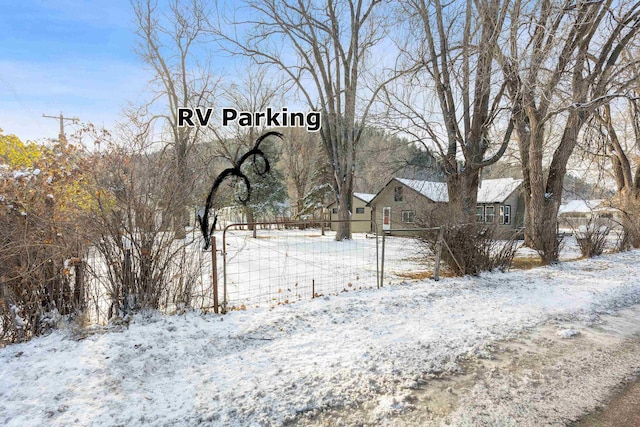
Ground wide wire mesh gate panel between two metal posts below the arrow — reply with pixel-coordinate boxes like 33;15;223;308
218;221;379;309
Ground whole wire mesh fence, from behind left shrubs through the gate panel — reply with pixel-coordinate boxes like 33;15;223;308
84;221;380;323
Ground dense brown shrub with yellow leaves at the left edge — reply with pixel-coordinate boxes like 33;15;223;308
0;133;92;344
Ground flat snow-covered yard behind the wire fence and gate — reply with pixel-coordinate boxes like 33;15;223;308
88;229;424;323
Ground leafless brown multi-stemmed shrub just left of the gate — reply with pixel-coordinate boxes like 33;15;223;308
85;144;201;319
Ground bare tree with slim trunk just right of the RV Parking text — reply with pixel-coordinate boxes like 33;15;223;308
218;0;393;240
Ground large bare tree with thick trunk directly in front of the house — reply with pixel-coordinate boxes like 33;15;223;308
385;0;513;223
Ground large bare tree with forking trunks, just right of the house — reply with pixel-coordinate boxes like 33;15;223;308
499;0;640;263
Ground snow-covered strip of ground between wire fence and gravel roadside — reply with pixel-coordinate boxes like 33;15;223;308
0;251;640;426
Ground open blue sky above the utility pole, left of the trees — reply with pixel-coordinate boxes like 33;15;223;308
0;0;150;140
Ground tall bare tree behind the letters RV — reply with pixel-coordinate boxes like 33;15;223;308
132;0;218;238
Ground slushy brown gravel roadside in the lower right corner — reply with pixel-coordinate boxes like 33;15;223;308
300;305;640;427
